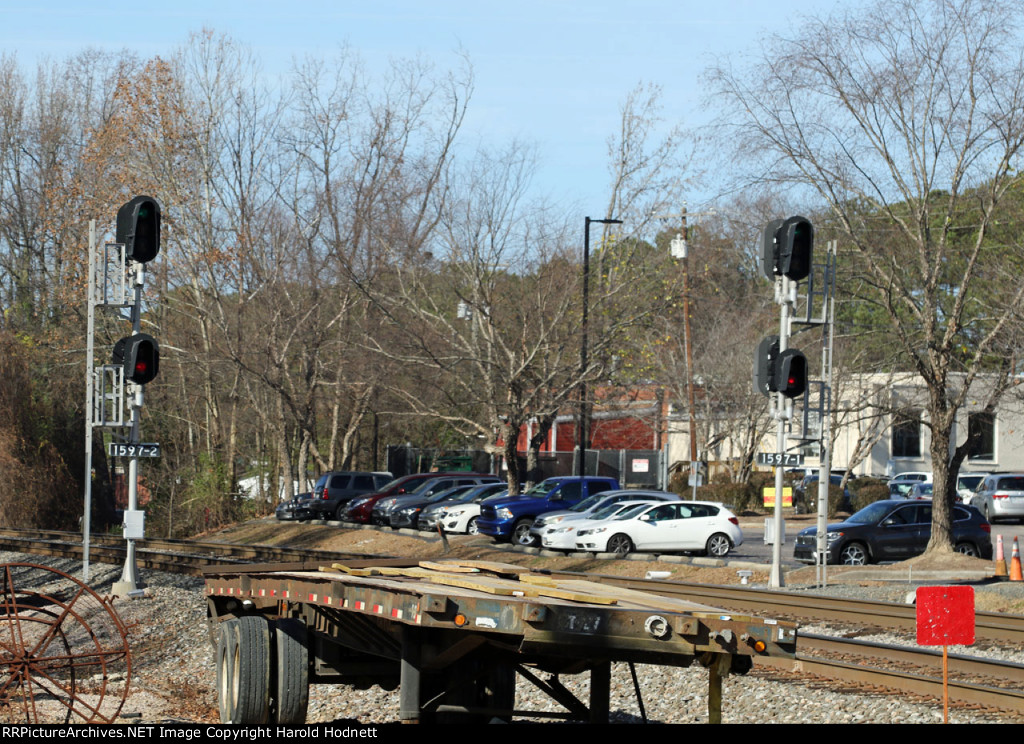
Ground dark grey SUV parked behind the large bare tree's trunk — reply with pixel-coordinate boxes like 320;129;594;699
793;499;992;566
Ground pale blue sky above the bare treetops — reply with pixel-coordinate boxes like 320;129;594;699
0;0;859;215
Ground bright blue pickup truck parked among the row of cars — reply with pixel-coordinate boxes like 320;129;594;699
476;476;618;546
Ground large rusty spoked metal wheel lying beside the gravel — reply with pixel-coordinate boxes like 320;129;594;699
0;563;131;724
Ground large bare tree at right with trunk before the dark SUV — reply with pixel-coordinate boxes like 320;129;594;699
711;0;1024;551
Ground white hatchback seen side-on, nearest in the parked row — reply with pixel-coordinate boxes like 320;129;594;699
575;501;743;558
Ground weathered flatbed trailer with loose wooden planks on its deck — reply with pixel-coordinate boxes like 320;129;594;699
205;559;797;725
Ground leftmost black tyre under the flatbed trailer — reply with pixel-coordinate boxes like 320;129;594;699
217;615;270;726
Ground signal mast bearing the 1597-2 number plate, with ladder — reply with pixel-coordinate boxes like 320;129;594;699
82;195;162;596
